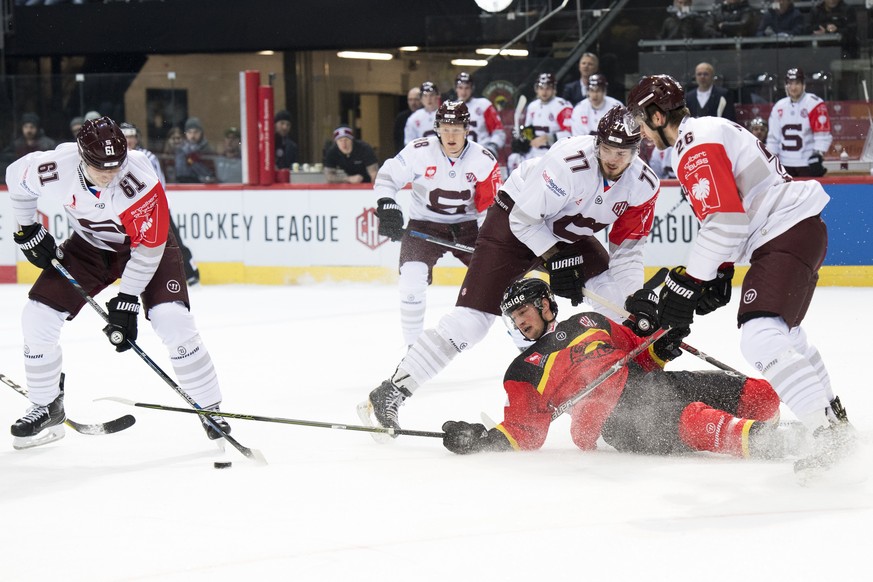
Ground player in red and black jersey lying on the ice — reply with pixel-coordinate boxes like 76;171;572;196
443;279;803;458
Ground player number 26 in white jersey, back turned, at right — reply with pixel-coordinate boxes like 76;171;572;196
628;75;854;480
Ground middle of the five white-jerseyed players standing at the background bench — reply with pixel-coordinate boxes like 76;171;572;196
506;73;573;173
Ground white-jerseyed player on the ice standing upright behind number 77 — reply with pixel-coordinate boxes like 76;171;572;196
373;101;501;345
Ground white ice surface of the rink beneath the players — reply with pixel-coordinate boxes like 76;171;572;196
0;284;873;582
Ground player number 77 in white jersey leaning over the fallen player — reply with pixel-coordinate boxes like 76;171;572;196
358;107;660;438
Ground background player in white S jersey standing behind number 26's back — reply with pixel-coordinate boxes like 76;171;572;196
767;68;834;177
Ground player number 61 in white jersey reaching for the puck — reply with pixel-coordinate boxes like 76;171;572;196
6;117;230;448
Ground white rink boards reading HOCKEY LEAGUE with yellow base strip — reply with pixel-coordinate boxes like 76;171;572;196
0;177;873;286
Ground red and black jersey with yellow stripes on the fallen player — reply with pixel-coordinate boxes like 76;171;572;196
497;312;664;450
